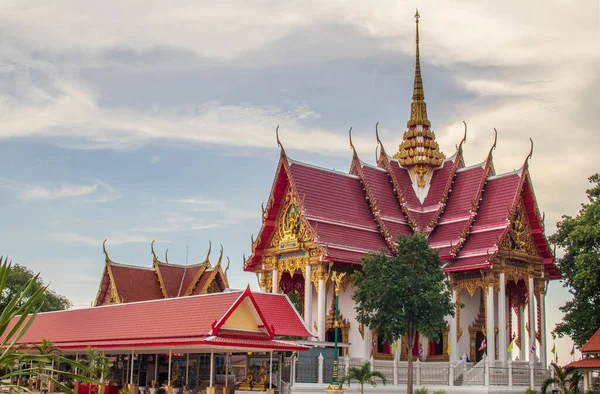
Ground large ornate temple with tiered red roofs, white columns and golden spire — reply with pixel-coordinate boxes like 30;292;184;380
244;13;559;363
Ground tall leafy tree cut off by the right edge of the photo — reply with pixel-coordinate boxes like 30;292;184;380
550;174;600;347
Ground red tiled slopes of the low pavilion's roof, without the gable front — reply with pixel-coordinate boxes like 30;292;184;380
9;290;310;347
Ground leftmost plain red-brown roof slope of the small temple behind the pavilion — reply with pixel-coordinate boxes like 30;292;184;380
110;262;163;302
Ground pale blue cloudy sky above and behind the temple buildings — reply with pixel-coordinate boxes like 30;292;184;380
0;0;600;364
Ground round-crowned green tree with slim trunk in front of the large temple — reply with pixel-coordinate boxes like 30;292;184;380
352;234;454;394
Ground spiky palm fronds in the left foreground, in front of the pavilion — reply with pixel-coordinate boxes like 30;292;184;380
0;257;96;394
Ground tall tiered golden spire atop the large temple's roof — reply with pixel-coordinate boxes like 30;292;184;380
394;10;446;188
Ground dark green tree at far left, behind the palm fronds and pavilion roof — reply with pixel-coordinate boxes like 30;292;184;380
0;264;71;313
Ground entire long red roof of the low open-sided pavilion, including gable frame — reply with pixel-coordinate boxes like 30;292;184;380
8;288;311;349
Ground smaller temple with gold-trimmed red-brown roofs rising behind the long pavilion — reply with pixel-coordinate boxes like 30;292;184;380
94;240;229;306
